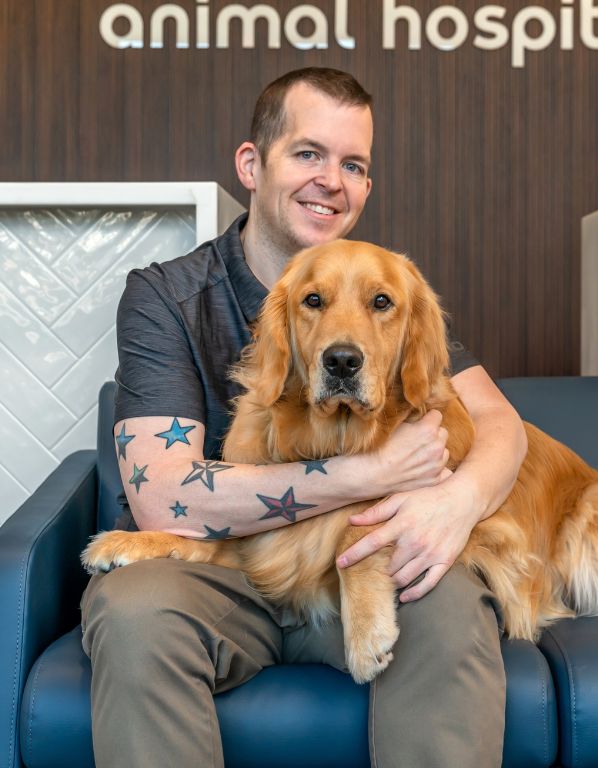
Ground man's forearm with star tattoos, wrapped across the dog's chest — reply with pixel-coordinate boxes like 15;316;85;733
127;456;369;539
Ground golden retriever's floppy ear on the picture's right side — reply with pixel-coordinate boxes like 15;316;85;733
400;260;449;409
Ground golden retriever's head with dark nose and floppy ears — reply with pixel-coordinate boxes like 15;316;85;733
236;240;448;418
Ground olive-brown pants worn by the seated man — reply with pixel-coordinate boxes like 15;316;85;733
82;560;505;768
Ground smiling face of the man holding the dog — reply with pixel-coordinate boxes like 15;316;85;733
251;83;373;256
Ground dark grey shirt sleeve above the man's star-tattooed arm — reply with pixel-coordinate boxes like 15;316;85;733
114;268;206;424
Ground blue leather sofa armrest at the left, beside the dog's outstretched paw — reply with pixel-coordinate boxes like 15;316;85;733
0;451;97;768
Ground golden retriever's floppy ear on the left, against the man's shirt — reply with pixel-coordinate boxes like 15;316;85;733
233;278;291;408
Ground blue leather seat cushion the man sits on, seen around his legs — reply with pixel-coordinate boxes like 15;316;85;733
20;627;556;768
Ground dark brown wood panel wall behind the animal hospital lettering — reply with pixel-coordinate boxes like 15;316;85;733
0;0;598;376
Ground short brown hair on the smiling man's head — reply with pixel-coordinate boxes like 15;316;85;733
251;67;372;165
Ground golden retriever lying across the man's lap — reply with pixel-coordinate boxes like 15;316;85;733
82;241;598;682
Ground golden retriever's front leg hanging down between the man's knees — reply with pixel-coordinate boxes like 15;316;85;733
337;526;399;683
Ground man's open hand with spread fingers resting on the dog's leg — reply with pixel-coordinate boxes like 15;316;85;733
337;470;479;603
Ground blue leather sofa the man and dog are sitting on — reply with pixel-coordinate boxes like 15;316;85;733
0;378;598;768
